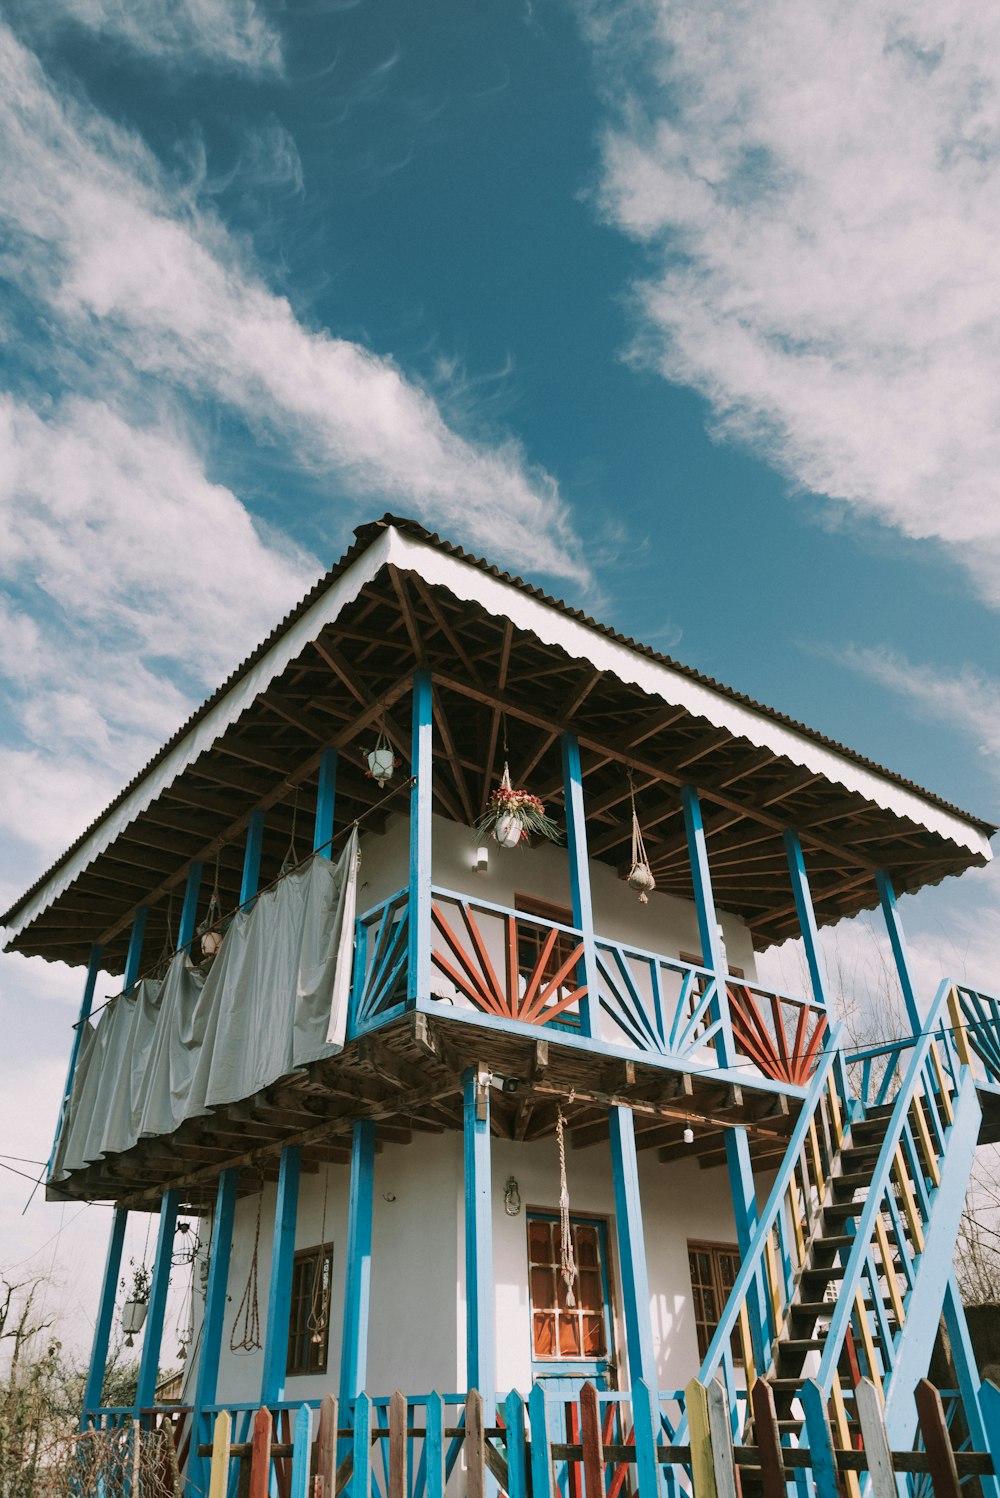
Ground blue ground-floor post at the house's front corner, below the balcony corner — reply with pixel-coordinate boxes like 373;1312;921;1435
463;1070;497;1402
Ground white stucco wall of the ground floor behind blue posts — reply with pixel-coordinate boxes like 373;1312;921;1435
211;1132;763;1401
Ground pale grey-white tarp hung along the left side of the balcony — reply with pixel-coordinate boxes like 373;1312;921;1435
52;828;358;1180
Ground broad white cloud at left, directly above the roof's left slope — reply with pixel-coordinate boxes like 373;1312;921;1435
0;397;320;857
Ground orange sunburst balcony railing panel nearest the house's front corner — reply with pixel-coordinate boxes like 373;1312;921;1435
431;900;587;1025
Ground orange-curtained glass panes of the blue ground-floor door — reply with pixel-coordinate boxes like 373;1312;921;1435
528;1216;608;1362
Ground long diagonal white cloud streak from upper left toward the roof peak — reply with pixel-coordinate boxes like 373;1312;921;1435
0;30;588;581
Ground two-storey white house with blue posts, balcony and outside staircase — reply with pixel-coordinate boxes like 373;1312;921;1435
4;517;1000;1492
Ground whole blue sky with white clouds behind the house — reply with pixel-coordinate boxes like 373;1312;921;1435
0;0;1000;1348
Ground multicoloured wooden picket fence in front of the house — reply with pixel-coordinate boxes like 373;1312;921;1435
193;1380;997;1498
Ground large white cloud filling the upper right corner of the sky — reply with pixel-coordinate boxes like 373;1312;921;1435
581;0;1000;605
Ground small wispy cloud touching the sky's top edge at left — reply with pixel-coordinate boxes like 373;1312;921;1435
36;0;281;73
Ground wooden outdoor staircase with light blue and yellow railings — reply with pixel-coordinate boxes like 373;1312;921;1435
679;984;982;1474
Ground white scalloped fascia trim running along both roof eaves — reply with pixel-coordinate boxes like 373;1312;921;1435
6;526;993;941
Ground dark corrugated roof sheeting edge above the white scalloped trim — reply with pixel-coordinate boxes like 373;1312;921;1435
0;514;997;923
